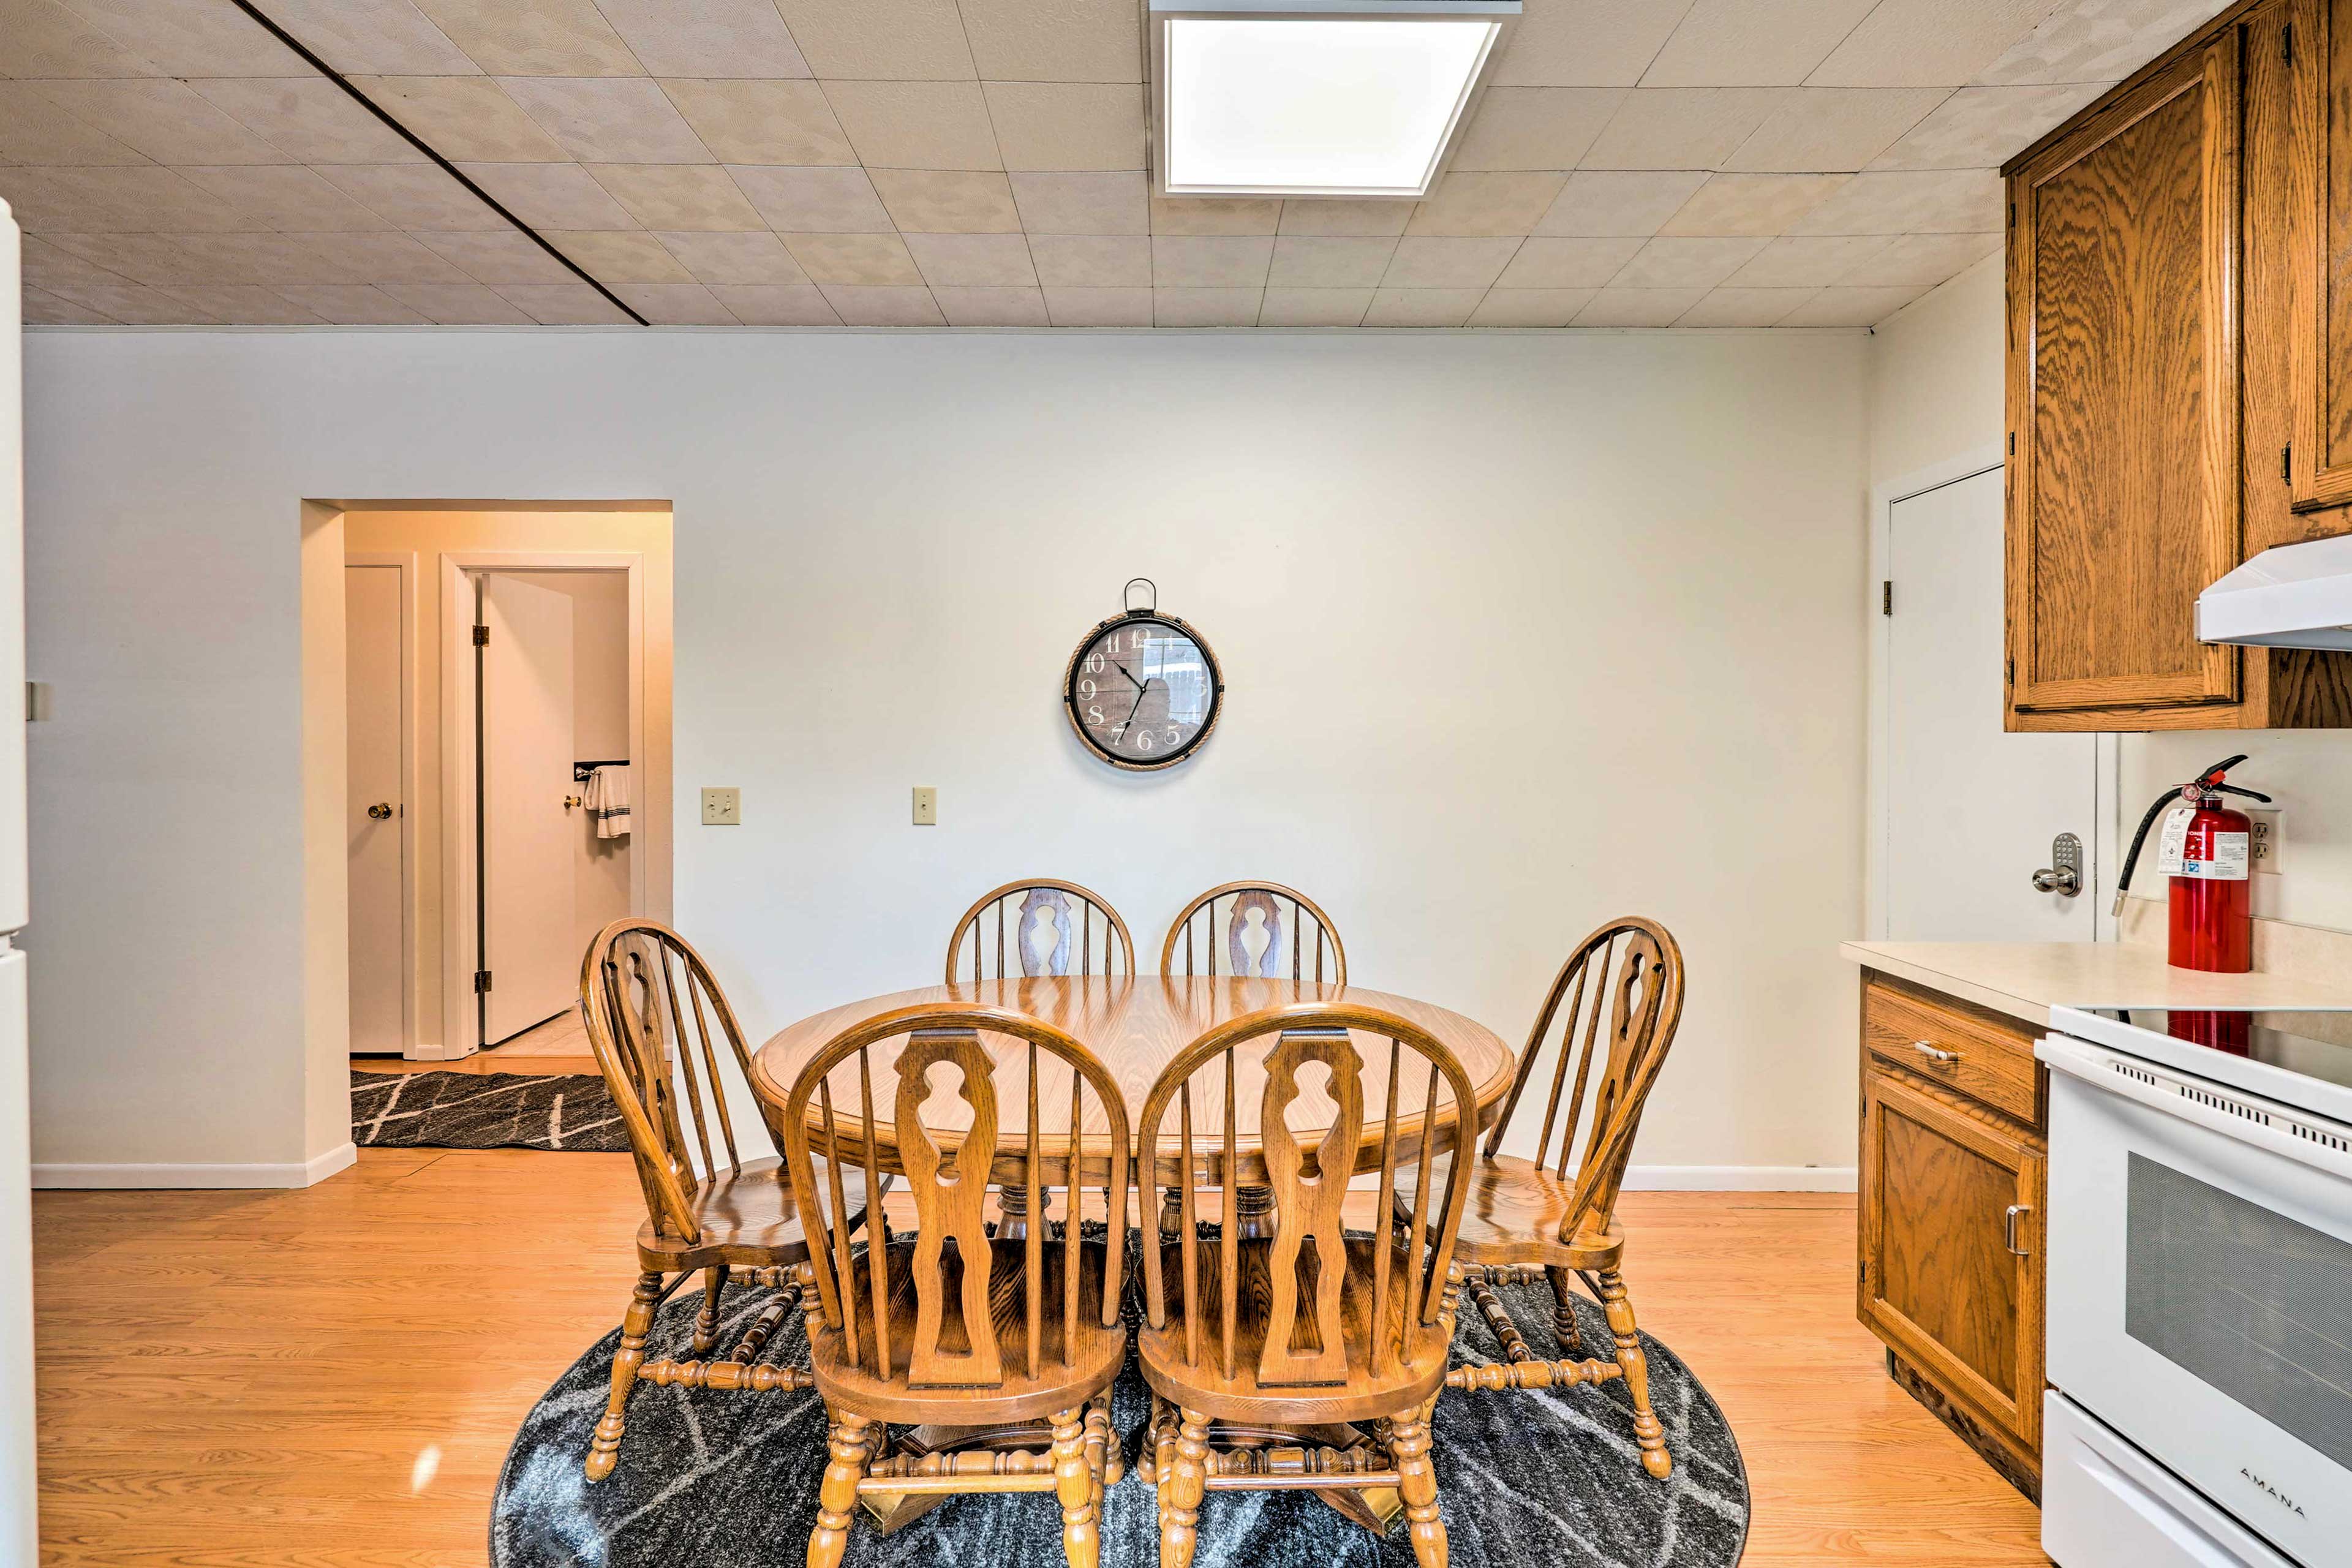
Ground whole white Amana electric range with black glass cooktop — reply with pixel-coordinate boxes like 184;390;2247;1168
2035;1006;2352;1568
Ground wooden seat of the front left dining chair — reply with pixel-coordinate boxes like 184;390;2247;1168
809;1237;1126;1427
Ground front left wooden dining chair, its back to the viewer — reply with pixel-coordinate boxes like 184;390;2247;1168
783;1004;1131;1568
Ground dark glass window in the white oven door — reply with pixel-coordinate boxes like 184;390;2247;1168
2124;1154;2352;1467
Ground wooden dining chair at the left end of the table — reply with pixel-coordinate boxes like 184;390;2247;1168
581;919;884;1481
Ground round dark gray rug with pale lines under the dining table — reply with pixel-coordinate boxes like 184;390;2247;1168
489;1284;1747;1568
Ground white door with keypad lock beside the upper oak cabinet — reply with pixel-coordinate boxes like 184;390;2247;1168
1882;468;2098;943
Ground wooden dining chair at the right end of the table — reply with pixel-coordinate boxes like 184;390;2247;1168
1411;917;1682;1481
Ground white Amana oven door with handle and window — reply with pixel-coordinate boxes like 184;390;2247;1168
2037;1035;2352;1568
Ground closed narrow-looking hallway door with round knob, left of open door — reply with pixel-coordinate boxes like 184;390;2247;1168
344;567;409;1055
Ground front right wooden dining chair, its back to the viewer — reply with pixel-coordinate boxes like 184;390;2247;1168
1136;1004;1477;1568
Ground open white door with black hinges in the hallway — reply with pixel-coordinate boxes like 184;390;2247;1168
475;576;581;1046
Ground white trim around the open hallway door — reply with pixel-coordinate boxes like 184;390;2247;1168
440;550;652;1060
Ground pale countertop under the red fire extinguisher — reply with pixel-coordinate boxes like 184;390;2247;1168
1839;943;2352;1025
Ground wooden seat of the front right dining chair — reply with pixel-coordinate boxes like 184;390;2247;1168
1136;1239;1449;1422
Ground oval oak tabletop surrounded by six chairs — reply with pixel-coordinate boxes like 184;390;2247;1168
753;976;1517;1180
